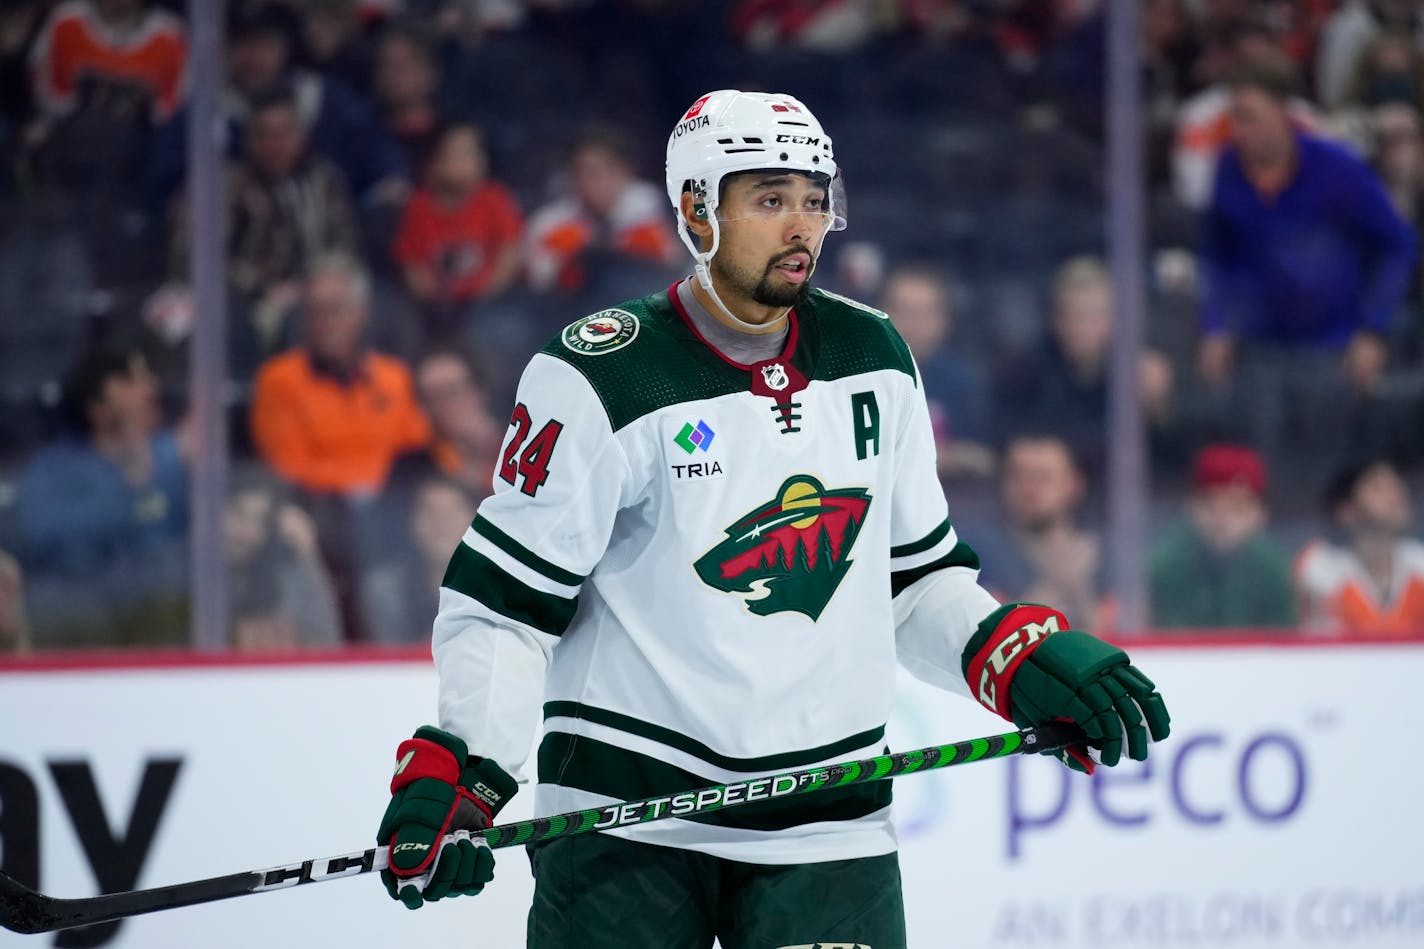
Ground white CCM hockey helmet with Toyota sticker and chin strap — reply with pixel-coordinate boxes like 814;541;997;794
666;88;846;285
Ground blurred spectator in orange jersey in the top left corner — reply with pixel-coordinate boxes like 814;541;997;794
30;0;188;121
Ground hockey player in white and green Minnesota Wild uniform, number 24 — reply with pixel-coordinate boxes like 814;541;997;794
377;90;1168;949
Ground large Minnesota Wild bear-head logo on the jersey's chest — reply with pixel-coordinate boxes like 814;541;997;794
693;475;871;620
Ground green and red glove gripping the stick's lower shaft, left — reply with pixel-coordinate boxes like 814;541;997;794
376;725;517;909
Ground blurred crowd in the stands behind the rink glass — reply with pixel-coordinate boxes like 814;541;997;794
0;0;1424;651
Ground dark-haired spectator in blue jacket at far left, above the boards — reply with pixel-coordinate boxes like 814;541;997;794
17;343;188;648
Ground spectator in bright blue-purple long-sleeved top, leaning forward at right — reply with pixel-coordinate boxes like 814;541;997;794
1199;52;1417;481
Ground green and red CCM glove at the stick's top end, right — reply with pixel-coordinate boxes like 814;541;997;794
963;603;1171;774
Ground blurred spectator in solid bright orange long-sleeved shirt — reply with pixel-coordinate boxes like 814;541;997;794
252;254;430;496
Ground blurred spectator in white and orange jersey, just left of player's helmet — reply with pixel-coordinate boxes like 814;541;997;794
525;131;678;292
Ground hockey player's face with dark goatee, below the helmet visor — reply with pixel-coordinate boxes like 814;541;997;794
712;172;830;306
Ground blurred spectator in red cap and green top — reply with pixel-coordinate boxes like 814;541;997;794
1148;445;1296;628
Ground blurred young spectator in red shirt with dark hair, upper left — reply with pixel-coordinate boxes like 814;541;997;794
394;124;524;336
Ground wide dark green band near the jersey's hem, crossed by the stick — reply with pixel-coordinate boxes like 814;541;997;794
538;731;891;831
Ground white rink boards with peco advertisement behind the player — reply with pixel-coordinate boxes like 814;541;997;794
0;645;1424;949
